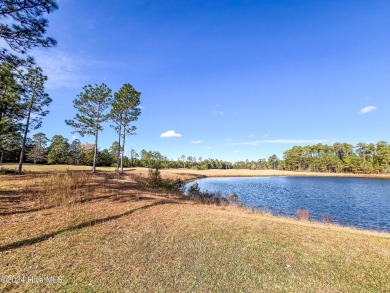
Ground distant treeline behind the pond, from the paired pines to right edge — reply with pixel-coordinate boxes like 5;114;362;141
128;141;390;174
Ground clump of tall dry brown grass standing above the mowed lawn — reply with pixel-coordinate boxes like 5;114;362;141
37;171;89;206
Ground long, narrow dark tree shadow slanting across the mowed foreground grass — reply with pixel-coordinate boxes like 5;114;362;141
0;200;177;252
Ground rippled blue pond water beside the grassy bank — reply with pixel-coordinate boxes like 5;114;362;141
187;177;390;232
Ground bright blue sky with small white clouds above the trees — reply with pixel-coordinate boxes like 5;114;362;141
24;0;390;161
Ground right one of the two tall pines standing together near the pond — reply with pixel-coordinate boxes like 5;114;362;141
110;83;141;173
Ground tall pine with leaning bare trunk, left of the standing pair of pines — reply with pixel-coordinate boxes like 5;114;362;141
18;67;52;174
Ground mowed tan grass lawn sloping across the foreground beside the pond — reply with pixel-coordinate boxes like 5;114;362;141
0;170;390;292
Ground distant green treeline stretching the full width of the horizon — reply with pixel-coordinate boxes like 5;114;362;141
0;132;390;173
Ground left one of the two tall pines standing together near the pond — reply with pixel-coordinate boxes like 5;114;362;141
65;83;111;173
